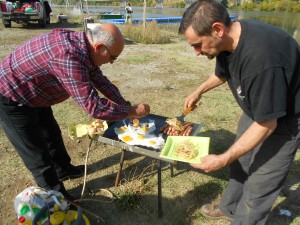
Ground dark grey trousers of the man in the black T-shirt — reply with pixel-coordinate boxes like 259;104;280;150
219;114;300;225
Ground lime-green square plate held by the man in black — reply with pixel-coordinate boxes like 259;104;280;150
160;136;210;163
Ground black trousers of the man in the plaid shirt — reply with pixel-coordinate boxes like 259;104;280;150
0;94;71;190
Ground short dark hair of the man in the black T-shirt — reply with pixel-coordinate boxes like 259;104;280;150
178;0;230;35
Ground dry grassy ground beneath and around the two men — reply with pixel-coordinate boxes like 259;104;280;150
0;20;300;225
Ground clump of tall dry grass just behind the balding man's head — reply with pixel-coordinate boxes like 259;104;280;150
121;21;171;44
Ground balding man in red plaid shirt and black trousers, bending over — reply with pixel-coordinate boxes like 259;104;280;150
0;24;150;200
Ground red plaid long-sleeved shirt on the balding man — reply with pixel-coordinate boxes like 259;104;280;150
0;29;129;120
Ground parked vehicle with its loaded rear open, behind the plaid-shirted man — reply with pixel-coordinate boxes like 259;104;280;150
0;0;52;28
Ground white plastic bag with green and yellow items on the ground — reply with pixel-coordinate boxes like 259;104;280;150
14;187;90;225
